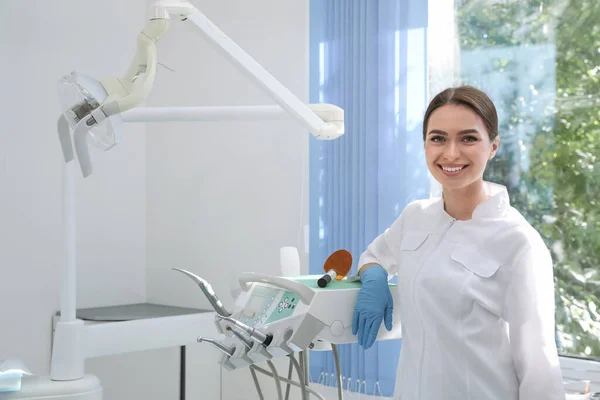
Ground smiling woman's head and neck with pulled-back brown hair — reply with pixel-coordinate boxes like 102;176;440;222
423;86;500;219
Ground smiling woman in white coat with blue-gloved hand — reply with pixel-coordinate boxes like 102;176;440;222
352;86;565;400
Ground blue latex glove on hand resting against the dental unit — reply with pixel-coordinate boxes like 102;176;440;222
352;265;394;349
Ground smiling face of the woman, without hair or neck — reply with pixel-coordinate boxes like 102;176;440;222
425;104;500;190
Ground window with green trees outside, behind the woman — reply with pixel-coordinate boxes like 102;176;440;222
455;0;600;358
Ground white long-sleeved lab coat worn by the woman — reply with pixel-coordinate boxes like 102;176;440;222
359;182;565;400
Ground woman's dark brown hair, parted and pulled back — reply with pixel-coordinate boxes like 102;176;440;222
423;86;498;141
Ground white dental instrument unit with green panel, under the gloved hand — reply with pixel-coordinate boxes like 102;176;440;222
178;271;401;398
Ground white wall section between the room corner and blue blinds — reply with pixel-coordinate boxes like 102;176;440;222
146;0;309;400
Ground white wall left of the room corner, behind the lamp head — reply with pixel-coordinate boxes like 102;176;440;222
0;0;157;399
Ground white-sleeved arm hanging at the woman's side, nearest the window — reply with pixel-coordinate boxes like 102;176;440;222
505;239;565;400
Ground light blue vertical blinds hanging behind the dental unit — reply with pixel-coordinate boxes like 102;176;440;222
310;0;429;396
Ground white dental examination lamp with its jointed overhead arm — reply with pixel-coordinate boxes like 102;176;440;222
58;0;344;177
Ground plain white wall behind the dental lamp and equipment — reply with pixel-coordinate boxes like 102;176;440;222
0;0;308;400
